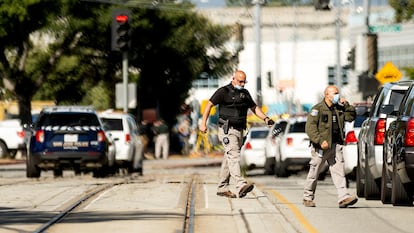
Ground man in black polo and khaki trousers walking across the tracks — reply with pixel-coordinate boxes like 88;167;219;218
199;70;274;198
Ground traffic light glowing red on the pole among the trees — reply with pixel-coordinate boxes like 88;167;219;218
111;9;131;51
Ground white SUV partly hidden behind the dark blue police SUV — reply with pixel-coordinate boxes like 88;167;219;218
99;112;144;175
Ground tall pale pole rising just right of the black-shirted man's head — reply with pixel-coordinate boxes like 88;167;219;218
253;0;263;107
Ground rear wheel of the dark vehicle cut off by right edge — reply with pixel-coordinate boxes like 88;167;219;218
391;157;413;206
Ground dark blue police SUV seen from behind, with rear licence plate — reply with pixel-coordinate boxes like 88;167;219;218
26;106;115;177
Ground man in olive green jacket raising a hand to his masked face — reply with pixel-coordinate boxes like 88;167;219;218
303;86;358;208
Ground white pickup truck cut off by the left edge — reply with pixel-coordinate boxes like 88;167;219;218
0;119;26;158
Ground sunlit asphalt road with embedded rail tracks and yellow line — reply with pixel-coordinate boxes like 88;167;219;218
0;156;414;233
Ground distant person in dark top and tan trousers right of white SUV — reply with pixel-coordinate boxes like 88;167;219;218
153;120;170;159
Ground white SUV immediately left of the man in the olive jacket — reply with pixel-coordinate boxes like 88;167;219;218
275;117;311;177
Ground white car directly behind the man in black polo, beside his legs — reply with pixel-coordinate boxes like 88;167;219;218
240;126;269;170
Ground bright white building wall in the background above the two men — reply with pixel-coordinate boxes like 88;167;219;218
239;40;349;110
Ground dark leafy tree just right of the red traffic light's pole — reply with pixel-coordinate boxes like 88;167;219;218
131;5;235;122
